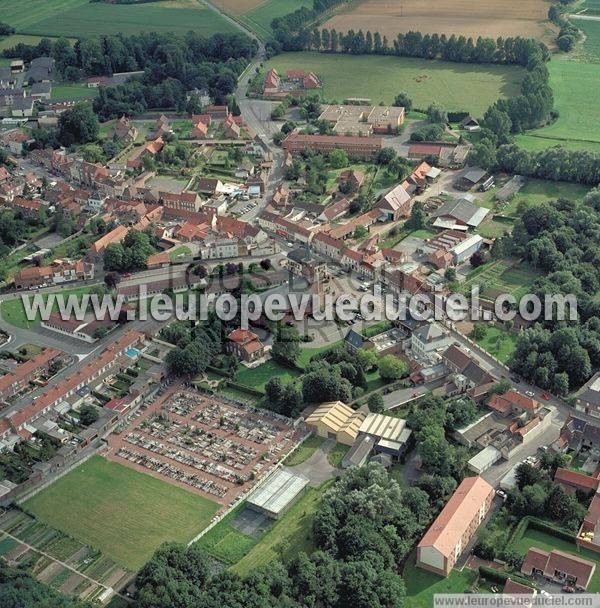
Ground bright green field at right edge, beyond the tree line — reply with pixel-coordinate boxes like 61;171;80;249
517;58;600;151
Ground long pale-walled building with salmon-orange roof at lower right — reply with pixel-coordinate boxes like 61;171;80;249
417;477;494;576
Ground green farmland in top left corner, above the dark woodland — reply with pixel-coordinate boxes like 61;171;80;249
0;0;237;38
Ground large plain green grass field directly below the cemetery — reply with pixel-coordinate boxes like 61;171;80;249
24;456;219;570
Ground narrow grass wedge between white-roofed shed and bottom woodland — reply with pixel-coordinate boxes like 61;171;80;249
231;482;332;576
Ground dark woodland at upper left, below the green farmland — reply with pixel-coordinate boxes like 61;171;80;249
4;32;257;120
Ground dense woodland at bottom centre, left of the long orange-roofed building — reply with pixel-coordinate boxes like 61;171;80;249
137;465;435;608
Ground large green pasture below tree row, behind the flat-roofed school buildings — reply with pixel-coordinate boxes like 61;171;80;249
266;53;524;116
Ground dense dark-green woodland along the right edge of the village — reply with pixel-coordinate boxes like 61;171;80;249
500;189;600;395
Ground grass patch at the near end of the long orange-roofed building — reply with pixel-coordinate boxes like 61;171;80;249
402;553;477;608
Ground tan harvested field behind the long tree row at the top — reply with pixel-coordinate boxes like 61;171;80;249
324;0;554;43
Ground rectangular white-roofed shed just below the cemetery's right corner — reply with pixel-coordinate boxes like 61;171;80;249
247;469;308;519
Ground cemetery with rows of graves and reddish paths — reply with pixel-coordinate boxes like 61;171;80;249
108;385;299;505
